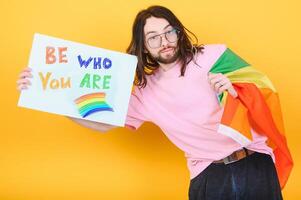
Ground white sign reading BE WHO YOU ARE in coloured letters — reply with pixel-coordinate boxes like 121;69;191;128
18;34;137;126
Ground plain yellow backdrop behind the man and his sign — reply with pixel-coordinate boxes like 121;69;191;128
0;0;301;200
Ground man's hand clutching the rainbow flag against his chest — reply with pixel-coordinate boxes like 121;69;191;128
208;72;238;98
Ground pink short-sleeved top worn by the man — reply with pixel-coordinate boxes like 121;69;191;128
126;44;274;179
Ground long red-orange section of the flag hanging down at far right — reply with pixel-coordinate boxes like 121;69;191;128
228;83;293;188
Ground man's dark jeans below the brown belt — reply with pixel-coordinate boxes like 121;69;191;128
189;152;282;200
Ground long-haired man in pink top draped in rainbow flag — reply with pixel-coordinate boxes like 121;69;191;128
17;6;292;200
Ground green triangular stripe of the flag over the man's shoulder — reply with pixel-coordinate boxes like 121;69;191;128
210;48;249;74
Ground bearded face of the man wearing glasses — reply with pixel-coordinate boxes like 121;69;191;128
144;17;178;64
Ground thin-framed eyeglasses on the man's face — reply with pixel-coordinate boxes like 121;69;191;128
147;29;179;49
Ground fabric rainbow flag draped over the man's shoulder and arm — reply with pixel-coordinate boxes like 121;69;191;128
210;48;293;188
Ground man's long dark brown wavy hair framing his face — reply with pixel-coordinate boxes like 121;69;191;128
126;6;204;88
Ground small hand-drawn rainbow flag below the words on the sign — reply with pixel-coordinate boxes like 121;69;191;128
74;92;114;118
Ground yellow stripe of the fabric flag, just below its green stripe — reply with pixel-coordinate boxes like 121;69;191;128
225;66;276;93
